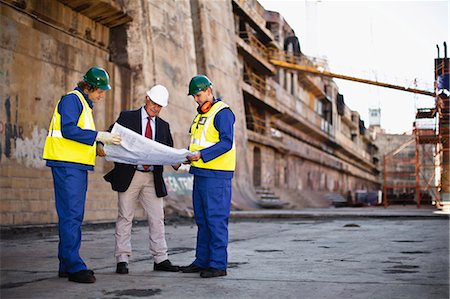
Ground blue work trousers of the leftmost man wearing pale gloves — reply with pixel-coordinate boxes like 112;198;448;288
52;167;88;273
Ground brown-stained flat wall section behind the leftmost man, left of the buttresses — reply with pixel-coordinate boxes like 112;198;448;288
0;2;120;225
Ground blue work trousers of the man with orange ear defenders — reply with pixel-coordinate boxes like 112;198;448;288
193;175;231;270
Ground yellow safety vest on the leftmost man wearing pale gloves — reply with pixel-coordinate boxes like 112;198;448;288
43;90;97;166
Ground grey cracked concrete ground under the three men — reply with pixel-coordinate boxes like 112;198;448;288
0;207;449;299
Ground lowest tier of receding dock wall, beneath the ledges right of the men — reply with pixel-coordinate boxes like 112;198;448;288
249;137;380;208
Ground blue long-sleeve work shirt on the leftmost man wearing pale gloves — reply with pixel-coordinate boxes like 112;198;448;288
46;87;98;170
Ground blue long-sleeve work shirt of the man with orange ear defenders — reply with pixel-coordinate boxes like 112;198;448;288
189;102;235;179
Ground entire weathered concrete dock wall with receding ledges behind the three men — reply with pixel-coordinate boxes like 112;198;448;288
0;0;386;226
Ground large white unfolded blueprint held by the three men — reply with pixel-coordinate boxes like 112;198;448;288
104;123;191;165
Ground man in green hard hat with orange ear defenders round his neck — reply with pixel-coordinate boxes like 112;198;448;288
180;75;236;278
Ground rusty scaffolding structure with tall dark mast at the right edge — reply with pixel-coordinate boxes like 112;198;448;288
383;43;450;208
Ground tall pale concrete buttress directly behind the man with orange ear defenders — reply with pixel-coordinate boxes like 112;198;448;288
186;0;253;208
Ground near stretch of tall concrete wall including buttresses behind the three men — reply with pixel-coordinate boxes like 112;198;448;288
0;0;252;225
